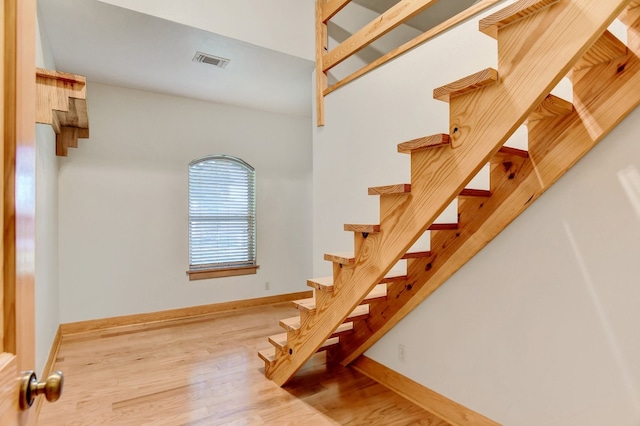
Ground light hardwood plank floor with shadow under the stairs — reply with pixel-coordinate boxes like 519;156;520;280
38;303;444;426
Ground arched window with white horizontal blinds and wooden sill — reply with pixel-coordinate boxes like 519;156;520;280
188;155;257;279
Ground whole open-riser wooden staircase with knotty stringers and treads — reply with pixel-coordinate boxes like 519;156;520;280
259;0;640;385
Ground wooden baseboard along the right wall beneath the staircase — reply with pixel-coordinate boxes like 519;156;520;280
352;355;499;426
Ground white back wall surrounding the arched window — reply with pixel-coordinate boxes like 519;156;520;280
59;84;312;323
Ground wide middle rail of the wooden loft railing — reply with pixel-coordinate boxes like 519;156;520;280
322;0;437;72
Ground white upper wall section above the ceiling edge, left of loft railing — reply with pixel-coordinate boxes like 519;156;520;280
95;0;315;61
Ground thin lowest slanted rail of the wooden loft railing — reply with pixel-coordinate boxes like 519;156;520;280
324;0;503;96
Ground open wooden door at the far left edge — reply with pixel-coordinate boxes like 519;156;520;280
0;0;36;426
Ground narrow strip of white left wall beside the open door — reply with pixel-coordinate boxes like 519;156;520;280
35;9;60;377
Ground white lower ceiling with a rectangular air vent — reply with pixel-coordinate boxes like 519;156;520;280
38;0;314;116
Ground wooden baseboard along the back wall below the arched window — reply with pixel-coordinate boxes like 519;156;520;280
60;291;313;338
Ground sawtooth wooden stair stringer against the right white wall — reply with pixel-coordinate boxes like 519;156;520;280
341;42;640;365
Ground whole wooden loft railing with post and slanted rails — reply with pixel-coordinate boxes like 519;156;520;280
316;0;503;126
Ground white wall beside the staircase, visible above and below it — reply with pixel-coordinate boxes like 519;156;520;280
313;1;640;426
